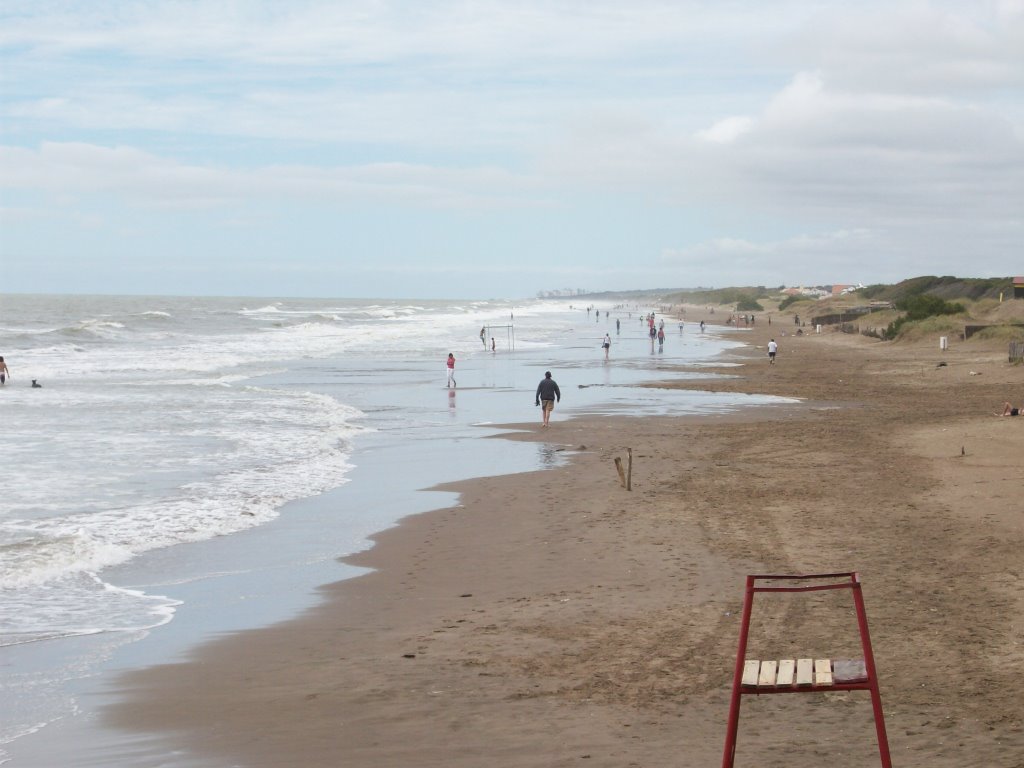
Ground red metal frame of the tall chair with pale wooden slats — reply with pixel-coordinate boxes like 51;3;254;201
722;571;892;768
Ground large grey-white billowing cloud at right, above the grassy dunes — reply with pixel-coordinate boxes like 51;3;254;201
546;63;1024;233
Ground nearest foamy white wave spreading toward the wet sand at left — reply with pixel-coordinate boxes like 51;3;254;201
0;339;364;641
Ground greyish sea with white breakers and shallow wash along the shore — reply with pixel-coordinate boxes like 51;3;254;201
0;296;790;765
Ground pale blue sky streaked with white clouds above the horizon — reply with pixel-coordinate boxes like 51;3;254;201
0;0;1024;299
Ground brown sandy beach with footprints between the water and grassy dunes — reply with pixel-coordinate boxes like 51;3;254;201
106;317;1024;768
